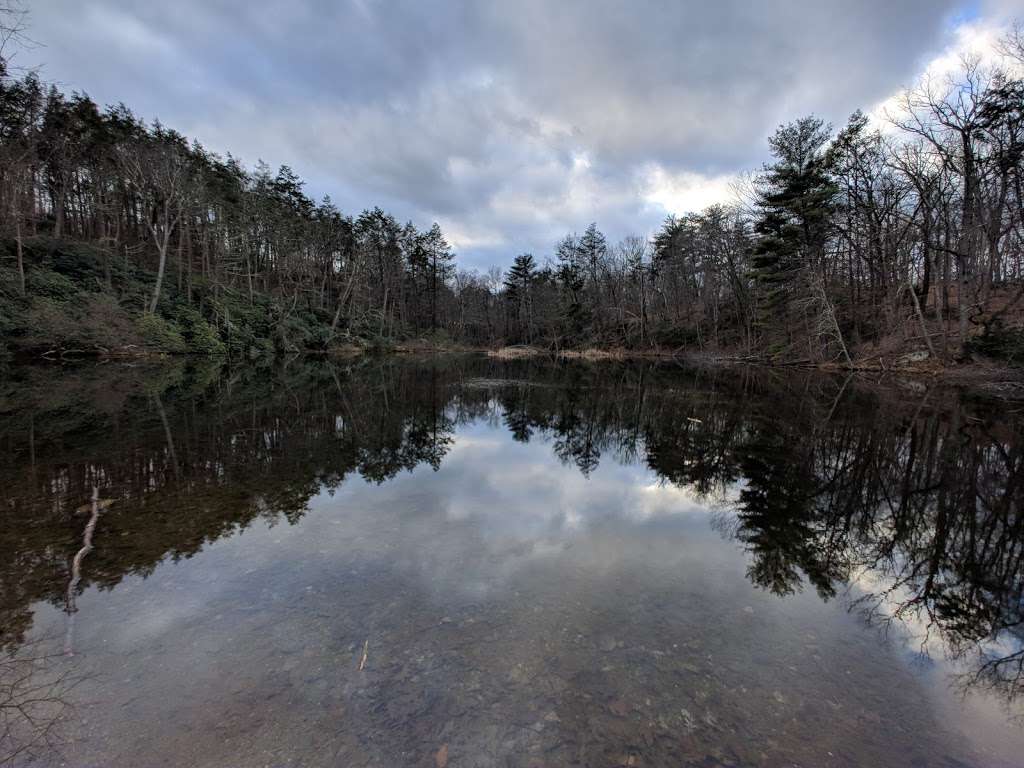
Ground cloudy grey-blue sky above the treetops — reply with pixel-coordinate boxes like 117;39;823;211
23;0;1024;268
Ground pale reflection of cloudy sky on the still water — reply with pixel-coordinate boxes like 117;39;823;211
18;421;1024;766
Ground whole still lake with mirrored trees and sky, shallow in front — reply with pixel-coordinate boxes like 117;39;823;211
0;356;1024;768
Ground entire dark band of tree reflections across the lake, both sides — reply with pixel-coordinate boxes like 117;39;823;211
0;357;1024;716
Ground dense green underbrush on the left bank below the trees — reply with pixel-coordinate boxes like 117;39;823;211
0;238;348;359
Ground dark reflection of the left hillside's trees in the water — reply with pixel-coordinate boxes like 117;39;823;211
0;364;455;644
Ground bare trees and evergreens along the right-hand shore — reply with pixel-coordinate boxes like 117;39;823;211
493;32;1024;362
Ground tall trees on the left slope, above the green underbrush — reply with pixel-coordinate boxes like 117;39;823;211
0;63;462;342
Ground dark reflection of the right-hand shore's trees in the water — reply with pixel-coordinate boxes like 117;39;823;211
477;368;1024;712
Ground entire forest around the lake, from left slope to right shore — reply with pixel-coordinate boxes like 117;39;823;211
0;28;1024;367
